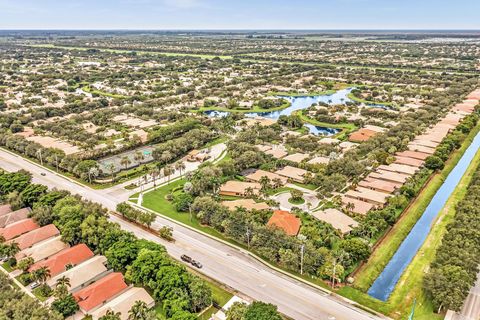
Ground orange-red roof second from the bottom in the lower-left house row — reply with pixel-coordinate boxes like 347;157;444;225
29;243;93;277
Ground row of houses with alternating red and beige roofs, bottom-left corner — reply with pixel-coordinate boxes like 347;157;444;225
0;205;155;319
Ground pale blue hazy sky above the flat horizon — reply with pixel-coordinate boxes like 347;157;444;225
0;0;480;30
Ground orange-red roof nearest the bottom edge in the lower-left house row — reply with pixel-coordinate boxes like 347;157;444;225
73;272;128;312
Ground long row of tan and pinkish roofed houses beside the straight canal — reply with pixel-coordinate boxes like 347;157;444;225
342;90;480;215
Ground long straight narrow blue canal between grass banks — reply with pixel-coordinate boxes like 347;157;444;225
368;129;480;301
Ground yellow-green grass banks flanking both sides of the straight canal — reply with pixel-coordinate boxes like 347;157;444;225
338;125;480;320
